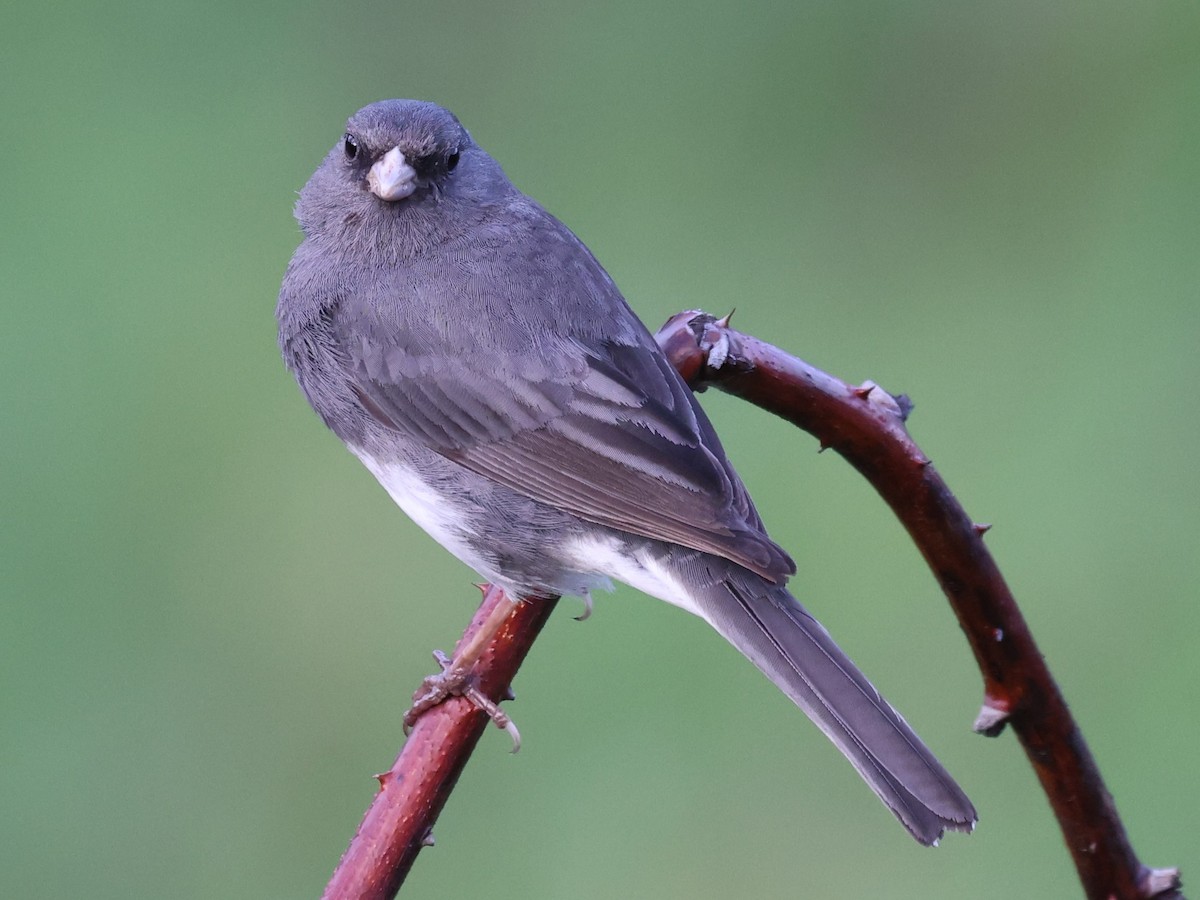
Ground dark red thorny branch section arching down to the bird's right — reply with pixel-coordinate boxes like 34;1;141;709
656;311;1182;900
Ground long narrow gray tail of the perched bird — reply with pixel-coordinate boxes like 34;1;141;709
671;552;977;845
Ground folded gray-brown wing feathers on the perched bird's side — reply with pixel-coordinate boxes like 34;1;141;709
347;309;794;582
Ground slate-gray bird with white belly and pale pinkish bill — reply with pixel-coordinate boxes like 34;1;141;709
276;100;976;844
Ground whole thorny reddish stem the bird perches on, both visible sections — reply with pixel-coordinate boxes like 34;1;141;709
324;312;1182;900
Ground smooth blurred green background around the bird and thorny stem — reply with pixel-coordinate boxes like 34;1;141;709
0;0;1200;900
